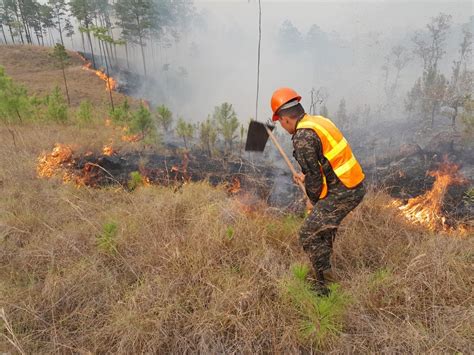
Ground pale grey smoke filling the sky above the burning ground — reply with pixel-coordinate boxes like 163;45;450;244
120;0;472;122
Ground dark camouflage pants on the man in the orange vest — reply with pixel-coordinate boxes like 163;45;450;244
300;184;365;284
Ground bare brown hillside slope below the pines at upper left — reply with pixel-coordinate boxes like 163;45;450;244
0;45;130;107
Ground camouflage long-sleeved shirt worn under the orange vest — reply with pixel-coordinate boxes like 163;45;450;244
292;128;356;204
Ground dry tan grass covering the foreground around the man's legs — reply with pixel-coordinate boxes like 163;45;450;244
0;126;474;354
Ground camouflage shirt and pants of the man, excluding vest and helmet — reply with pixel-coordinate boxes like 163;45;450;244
292;128;365;285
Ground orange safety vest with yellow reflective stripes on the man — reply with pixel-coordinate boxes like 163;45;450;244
296;115;365;199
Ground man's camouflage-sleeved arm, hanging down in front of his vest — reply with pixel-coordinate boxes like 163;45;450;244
293;128;323;203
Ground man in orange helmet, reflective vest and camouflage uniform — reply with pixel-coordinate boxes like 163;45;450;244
271;88;365;294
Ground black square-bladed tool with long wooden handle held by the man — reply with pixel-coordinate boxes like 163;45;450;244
245;121;313;209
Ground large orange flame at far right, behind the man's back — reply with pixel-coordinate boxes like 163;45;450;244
397;163;464;231
